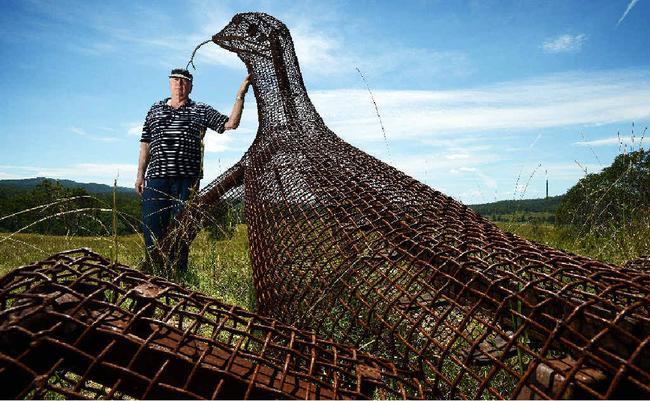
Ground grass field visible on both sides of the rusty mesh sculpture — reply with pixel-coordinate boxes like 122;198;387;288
0;217;650;310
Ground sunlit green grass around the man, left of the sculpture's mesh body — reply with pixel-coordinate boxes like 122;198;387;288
0;225;255;310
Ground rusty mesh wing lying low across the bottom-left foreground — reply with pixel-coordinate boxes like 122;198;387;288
0;249;425;399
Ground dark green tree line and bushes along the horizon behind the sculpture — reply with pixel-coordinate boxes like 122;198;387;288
0;149;650;239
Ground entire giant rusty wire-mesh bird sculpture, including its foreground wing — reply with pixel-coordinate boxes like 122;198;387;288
0;13;650;399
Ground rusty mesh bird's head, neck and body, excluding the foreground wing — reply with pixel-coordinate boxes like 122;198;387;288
158;13;650;398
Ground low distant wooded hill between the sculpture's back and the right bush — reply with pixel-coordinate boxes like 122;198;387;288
468;195;564;222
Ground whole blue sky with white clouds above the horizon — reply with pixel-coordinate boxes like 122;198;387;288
0;0;650;204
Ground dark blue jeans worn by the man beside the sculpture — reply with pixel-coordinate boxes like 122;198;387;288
142;177;199;269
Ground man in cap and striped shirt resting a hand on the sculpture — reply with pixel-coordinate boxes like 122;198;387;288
135;68;250;269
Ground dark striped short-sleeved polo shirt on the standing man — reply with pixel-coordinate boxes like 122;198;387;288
140;98;228;178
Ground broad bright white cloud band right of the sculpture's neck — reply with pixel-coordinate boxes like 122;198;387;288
310;70;650;143
